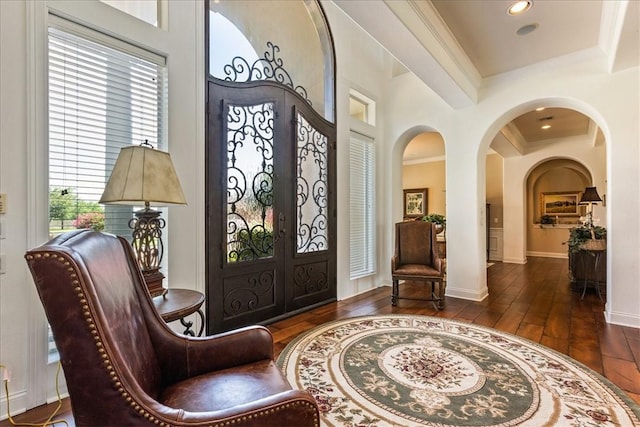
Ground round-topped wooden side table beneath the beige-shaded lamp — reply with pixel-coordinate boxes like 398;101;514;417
153;289;204;337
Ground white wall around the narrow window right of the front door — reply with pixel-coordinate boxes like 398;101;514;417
322;2;393;299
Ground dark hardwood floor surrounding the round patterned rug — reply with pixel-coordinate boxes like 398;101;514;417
0;258;640;427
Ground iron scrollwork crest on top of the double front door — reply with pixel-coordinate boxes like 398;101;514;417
223;41;311;105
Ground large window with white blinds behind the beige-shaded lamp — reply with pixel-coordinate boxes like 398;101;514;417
48;16;166;239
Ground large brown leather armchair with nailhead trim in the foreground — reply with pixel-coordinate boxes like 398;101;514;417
25;230;319;427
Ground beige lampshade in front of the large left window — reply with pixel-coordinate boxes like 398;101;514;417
100;145;187;206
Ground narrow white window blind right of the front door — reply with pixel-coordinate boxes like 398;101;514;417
349;133;376;279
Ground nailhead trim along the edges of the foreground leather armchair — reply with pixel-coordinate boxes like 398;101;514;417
26;252;320;427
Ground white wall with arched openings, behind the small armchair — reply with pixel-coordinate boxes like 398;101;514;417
383;63;640;327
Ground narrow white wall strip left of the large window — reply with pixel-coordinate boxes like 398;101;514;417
0;2;33;407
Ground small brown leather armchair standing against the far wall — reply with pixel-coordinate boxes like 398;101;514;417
391;221;445;310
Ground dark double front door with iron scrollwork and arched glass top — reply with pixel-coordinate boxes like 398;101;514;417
205;1;336;333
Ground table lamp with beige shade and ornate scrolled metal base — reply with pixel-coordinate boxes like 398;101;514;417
100;141;187;297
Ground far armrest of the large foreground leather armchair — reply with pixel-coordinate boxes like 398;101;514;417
156;325;273;382
